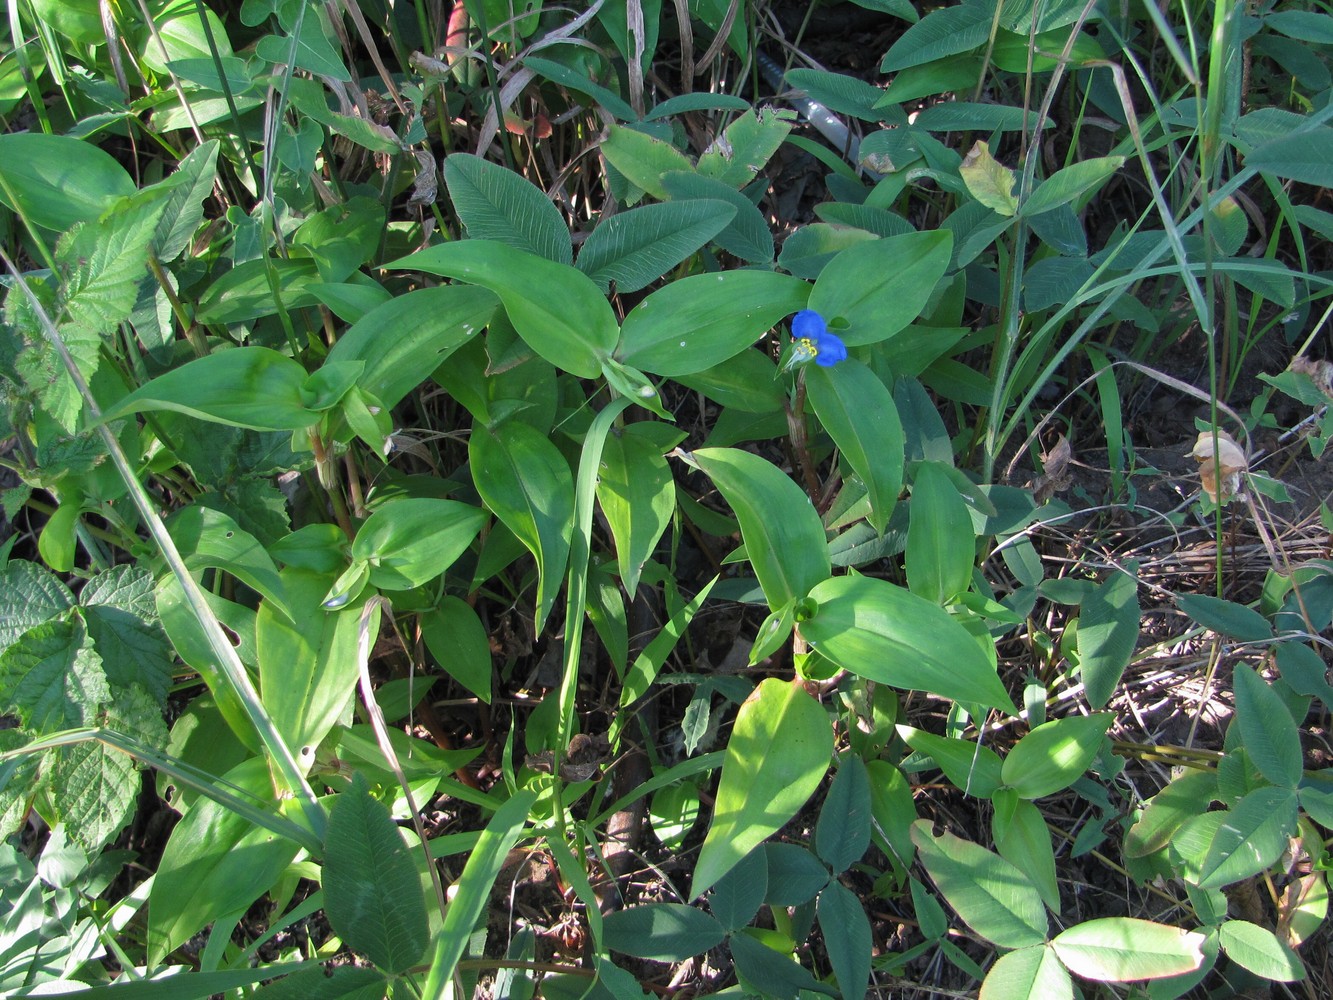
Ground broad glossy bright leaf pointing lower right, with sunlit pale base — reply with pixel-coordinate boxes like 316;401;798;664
794;576;1017;713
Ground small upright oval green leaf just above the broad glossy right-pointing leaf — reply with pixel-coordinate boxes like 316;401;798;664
904;461;977;604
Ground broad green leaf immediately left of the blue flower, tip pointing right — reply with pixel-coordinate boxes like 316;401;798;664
616;271;809;377
